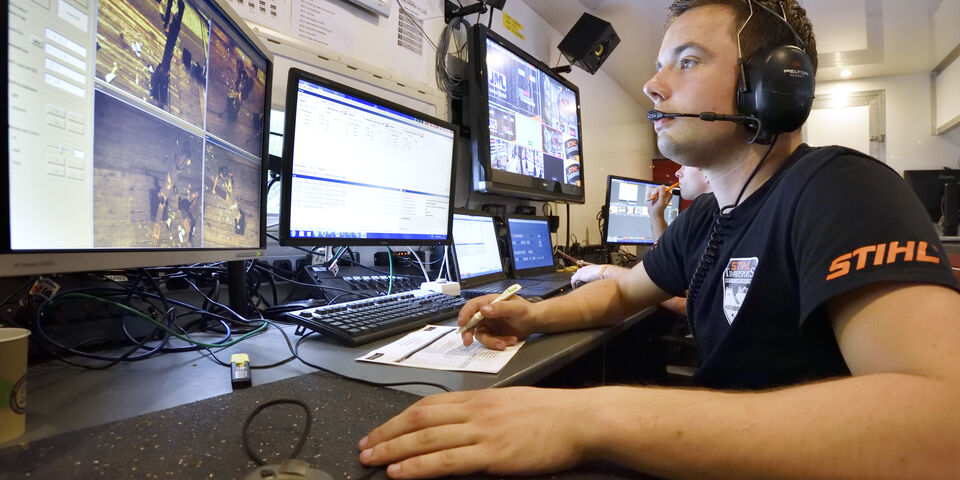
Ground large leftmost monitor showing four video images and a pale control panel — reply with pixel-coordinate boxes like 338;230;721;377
0;0;273;276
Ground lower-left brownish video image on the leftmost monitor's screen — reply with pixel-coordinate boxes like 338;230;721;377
93;92;203;248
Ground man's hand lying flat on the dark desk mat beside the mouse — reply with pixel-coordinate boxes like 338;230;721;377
359;388;592;478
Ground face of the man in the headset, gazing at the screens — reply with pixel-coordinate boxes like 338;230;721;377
643;5;745;167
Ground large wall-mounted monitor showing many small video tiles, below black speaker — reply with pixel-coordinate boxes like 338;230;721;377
468;25;584;203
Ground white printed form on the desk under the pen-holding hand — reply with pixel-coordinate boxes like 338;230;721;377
357;325;524;374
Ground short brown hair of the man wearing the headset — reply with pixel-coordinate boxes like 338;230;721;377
667;0;817;73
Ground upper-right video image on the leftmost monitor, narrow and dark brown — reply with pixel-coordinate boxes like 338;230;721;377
207;24;267;156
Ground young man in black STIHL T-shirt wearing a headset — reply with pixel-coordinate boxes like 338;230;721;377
359;0;960;478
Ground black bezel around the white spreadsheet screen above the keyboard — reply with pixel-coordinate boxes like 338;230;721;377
279;68;460;247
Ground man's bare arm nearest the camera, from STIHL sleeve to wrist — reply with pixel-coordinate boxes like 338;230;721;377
586;285;960;478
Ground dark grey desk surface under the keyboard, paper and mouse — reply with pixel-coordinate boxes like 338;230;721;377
0;309;653;478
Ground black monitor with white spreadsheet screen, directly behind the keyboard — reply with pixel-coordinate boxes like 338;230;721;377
280;69;458;245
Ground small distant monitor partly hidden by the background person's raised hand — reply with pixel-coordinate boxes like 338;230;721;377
603;175;680;245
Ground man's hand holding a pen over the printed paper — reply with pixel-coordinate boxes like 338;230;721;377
457;294;537;350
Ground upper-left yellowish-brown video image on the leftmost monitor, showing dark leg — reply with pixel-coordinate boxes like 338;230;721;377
96;0;209;127
